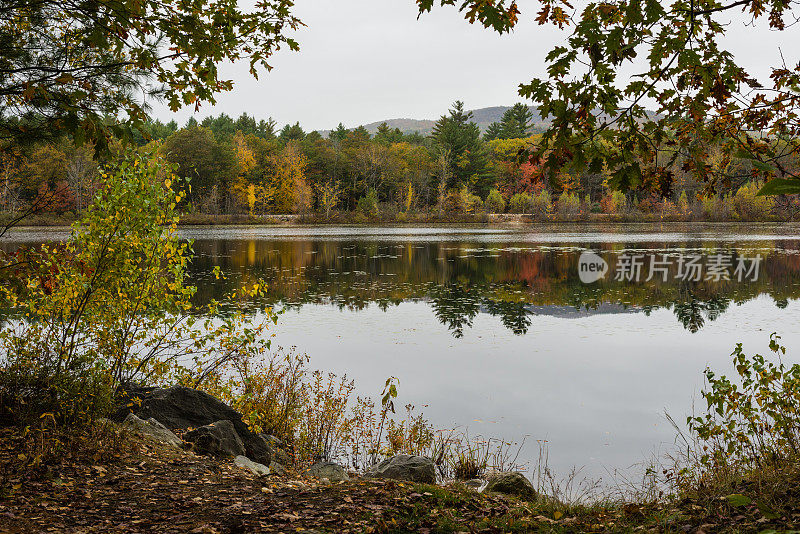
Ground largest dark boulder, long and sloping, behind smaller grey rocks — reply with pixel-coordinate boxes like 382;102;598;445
115;386;272;465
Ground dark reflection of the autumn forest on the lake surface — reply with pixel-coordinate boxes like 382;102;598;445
192;234;800;338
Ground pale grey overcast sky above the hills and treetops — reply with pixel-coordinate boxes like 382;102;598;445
147;0;800;130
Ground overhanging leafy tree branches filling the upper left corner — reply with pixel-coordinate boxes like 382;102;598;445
0;0;301;150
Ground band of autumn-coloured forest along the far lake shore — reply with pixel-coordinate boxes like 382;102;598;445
0;102;800;220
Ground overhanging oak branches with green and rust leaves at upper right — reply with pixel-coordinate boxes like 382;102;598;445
416;0;800;197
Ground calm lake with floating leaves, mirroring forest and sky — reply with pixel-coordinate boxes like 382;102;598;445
3;224;800;490
